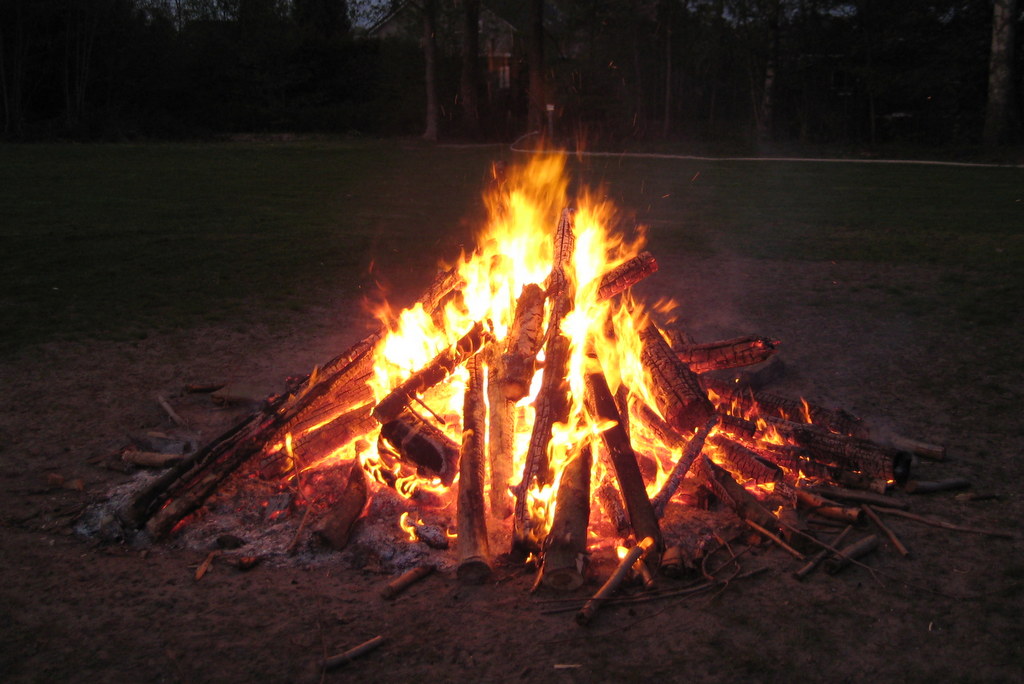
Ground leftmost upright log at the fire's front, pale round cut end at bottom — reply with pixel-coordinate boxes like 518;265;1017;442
457;356;490;585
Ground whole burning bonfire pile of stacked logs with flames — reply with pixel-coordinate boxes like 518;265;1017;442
79;156;1007;624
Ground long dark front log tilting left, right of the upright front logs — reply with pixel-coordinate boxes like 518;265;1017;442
587;362;662;568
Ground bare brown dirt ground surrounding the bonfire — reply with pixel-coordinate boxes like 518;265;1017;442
0;259;1024;682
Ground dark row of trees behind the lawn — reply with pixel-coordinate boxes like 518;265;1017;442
0;0;1024;144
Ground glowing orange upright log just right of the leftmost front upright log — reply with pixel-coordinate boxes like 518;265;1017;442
486;346;515;520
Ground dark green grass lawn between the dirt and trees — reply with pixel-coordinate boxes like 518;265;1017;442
0;141;1024;352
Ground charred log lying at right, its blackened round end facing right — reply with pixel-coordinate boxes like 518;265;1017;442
768;418;910;482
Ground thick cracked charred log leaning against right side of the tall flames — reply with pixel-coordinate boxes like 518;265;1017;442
640;324;715;432
